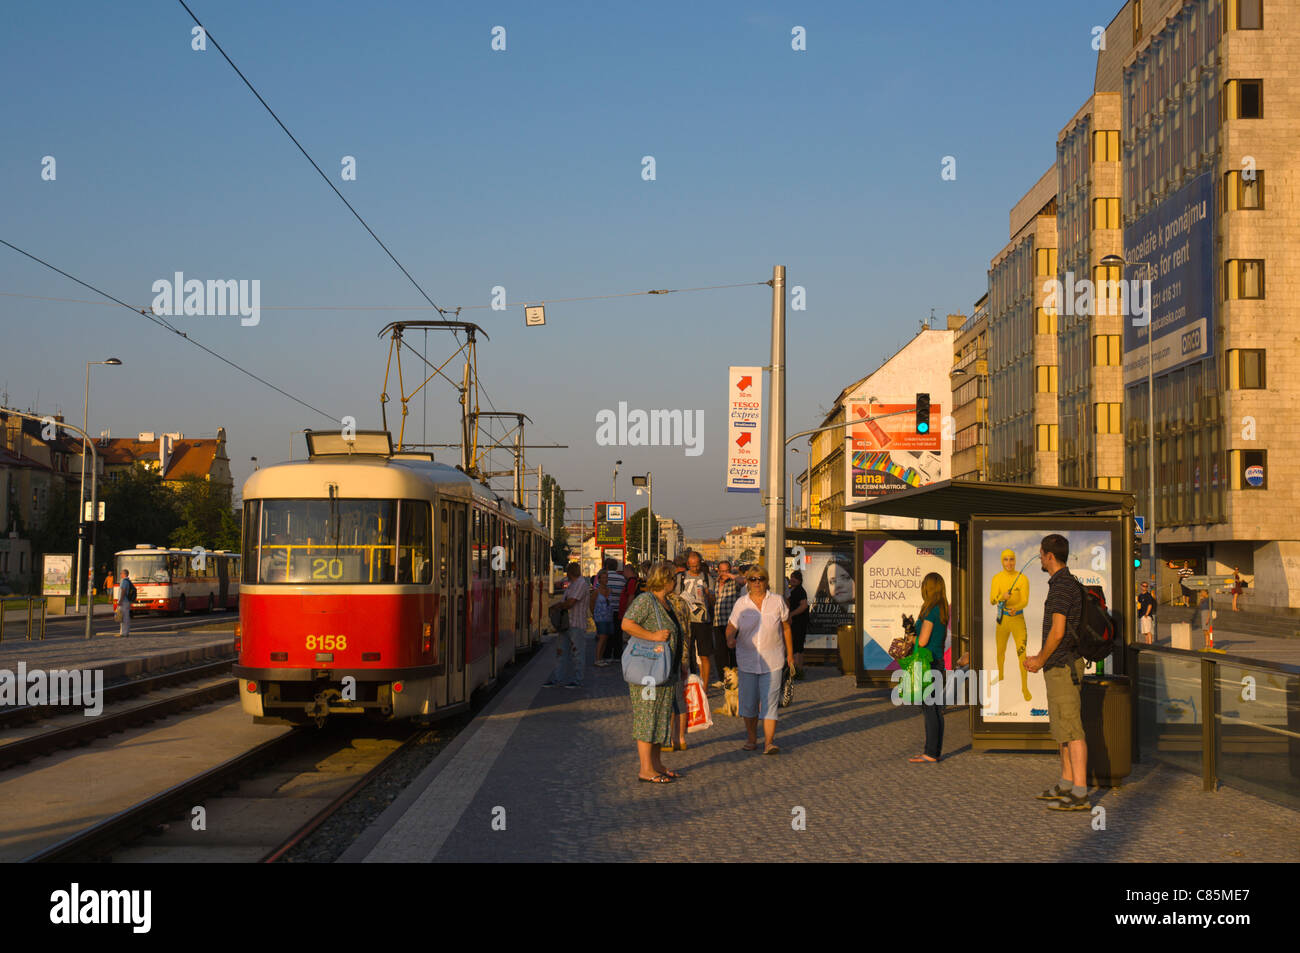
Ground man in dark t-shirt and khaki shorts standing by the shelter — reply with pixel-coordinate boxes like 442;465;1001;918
1024;533;1092;811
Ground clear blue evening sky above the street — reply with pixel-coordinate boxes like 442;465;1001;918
0;0;1121;536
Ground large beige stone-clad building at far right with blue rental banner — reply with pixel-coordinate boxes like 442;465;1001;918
1092;0;1300;607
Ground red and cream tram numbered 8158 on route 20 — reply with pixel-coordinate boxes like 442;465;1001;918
234;430;550;723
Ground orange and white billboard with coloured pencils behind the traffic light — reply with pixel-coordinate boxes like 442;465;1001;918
845;400;952;501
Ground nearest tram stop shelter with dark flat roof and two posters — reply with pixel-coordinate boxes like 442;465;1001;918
845;480;1136;761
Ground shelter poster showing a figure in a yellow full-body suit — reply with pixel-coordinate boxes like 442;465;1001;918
975;528;1115;724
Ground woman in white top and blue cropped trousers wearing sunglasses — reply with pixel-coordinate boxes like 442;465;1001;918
727;567;794;754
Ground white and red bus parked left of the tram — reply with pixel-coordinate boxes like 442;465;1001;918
113;543;241;612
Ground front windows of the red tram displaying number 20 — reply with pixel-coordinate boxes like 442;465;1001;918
244;498;433;585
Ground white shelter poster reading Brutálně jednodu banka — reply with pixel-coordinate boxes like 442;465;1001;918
854;530;958;685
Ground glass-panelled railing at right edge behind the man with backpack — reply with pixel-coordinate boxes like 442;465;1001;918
1128;645;1300;809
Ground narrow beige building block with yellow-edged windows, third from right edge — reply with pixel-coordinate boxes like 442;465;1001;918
988;164;1060;486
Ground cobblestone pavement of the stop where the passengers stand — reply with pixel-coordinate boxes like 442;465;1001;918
356;634;1300;862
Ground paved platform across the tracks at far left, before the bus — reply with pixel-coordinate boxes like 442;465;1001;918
0;616;234;685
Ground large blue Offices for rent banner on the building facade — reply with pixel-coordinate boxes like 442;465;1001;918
1122;172;1217;385
